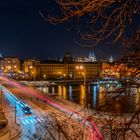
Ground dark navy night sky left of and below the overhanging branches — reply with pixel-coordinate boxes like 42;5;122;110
0;0;133;59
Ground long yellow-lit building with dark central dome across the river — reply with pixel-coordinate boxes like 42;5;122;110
36;53;102;79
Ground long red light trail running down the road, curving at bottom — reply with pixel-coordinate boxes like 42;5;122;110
3;77;104;140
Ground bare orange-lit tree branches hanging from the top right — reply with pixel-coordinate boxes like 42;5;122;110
40;0;140;47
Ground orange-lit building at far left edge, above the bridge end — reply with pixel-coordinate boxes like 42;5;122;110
3;57;20;78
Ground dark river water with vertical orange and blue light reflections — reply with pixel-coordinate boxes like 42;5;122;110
37;83;140;113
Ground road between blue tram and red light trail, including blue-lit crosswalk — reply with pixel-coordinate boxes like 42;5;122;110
4;83;87;140
